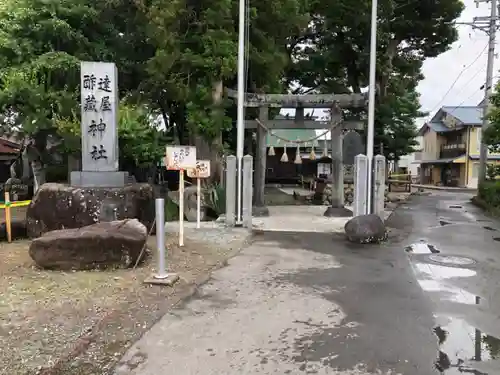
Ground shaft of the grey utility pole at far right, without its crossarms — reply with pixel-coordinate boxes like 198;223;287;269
479;0;497;183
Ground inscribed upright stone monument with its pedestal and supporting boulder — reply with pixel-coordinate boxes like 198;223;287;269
26;62;155;238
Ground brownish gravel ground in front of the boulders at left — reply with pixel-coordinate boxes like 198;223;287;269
0;225;249;375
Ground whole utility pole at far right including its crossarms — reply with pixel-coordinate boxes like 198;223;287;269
471;0;498;183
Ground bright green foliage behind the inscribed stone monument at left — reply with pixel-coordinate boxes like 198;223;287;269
0;0;152;185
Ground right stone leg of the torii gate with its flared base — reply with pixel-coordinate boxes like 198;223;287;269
324;125;352;217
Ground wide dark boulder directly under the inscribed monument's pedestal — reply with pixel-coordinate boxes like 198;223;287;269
26;183;155;238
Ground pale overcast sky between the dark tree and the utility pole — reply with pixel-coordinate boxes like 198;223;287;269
419;0;500;123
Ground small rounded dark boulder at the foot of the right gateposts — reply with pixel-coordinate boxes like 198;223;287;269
344;214;387;243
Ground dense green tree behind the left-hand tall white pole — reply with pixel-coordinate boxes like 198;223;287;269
140;0;308;182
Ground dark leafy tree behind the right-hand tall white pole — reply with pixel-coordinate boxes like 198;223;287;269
289;0;463;159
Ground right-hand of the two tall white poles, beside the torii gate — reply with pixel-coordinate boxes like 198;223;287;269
366;0;377;214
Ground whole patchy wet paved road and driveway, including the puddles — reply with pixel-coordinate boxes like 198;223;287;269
115;192;500;375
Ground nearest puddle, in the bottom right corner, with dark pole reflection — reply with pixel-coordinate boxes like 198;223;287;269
434;312;500;375
